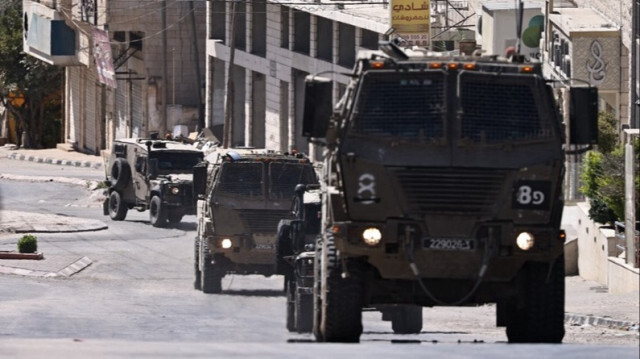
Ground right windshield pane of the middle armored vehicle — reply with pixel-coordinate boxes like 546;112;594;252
269;162;317;199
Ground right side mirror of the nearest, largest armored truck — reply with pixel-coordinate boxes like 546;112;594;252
569;87;598;145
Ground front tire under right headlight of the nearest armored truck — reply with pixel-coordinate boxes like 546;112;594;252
507;255;565;343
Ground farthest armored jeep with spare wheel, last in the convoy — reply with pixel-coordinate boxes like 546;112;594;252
103;138;204;227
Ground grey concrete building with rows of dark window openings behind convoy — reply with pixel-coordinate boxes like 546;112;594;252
206;0;478;158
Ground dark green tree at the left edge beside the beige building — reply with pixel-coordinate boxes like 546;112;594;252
0;0;63;147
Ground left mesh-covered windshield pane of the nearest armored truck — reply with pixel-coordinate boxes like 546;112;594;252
350;72;445;141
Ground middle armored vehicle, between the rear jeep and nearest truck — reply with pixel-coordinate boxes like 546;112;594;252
194;148;318;293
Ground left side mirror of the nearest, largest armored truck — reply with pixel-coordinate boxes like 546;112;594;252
302;75;333;138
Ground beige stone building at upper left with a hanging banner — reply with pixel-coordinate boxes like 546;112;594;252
23;0;206;154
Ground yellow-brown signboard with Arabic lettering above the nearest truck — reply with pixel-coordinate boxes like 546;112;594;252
390;0;431;47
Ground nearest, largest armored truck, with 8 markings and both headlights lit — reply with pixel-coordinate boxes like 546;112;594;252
303;42;597;343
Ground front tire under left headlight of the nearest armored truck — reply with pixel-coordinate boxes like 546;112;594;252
314;236;363;343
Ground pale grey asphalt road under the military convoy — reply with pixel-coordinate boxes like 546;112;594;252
0;159;638;358
